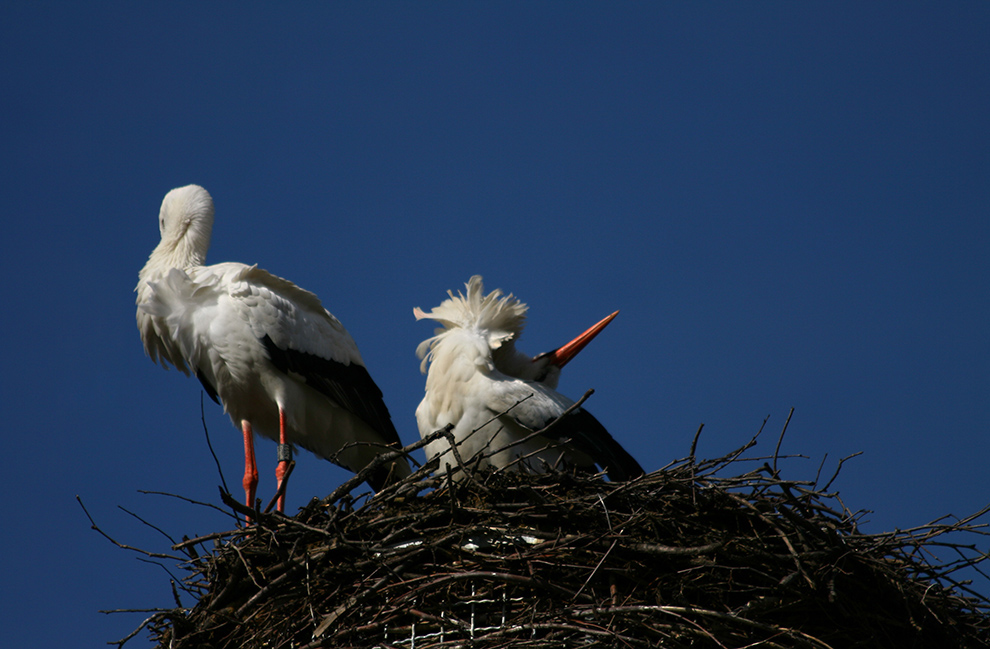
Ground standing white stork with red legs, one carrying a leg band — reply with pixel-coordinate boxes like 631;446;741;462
135;185;409;511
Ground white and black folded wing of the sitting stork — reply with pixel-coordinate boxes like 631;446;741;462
492;380;644;480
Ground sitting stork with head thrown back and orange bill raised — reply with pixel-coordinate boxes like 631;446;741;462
413;275;643;480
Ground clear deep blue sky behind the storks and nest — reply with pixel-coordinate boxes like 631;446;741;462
0;2;990;647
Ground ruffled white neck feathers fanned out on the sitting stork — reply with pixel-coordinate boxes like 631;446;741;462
413;275;529;373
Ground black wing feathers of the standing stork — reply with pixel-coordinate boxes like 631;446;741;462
261;334;401;446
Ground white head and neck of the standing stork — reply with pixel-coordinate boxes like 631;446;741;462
158;185;213;268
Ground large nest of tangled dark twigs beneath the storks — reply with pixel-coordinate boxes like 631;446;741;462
102;422;990;649
